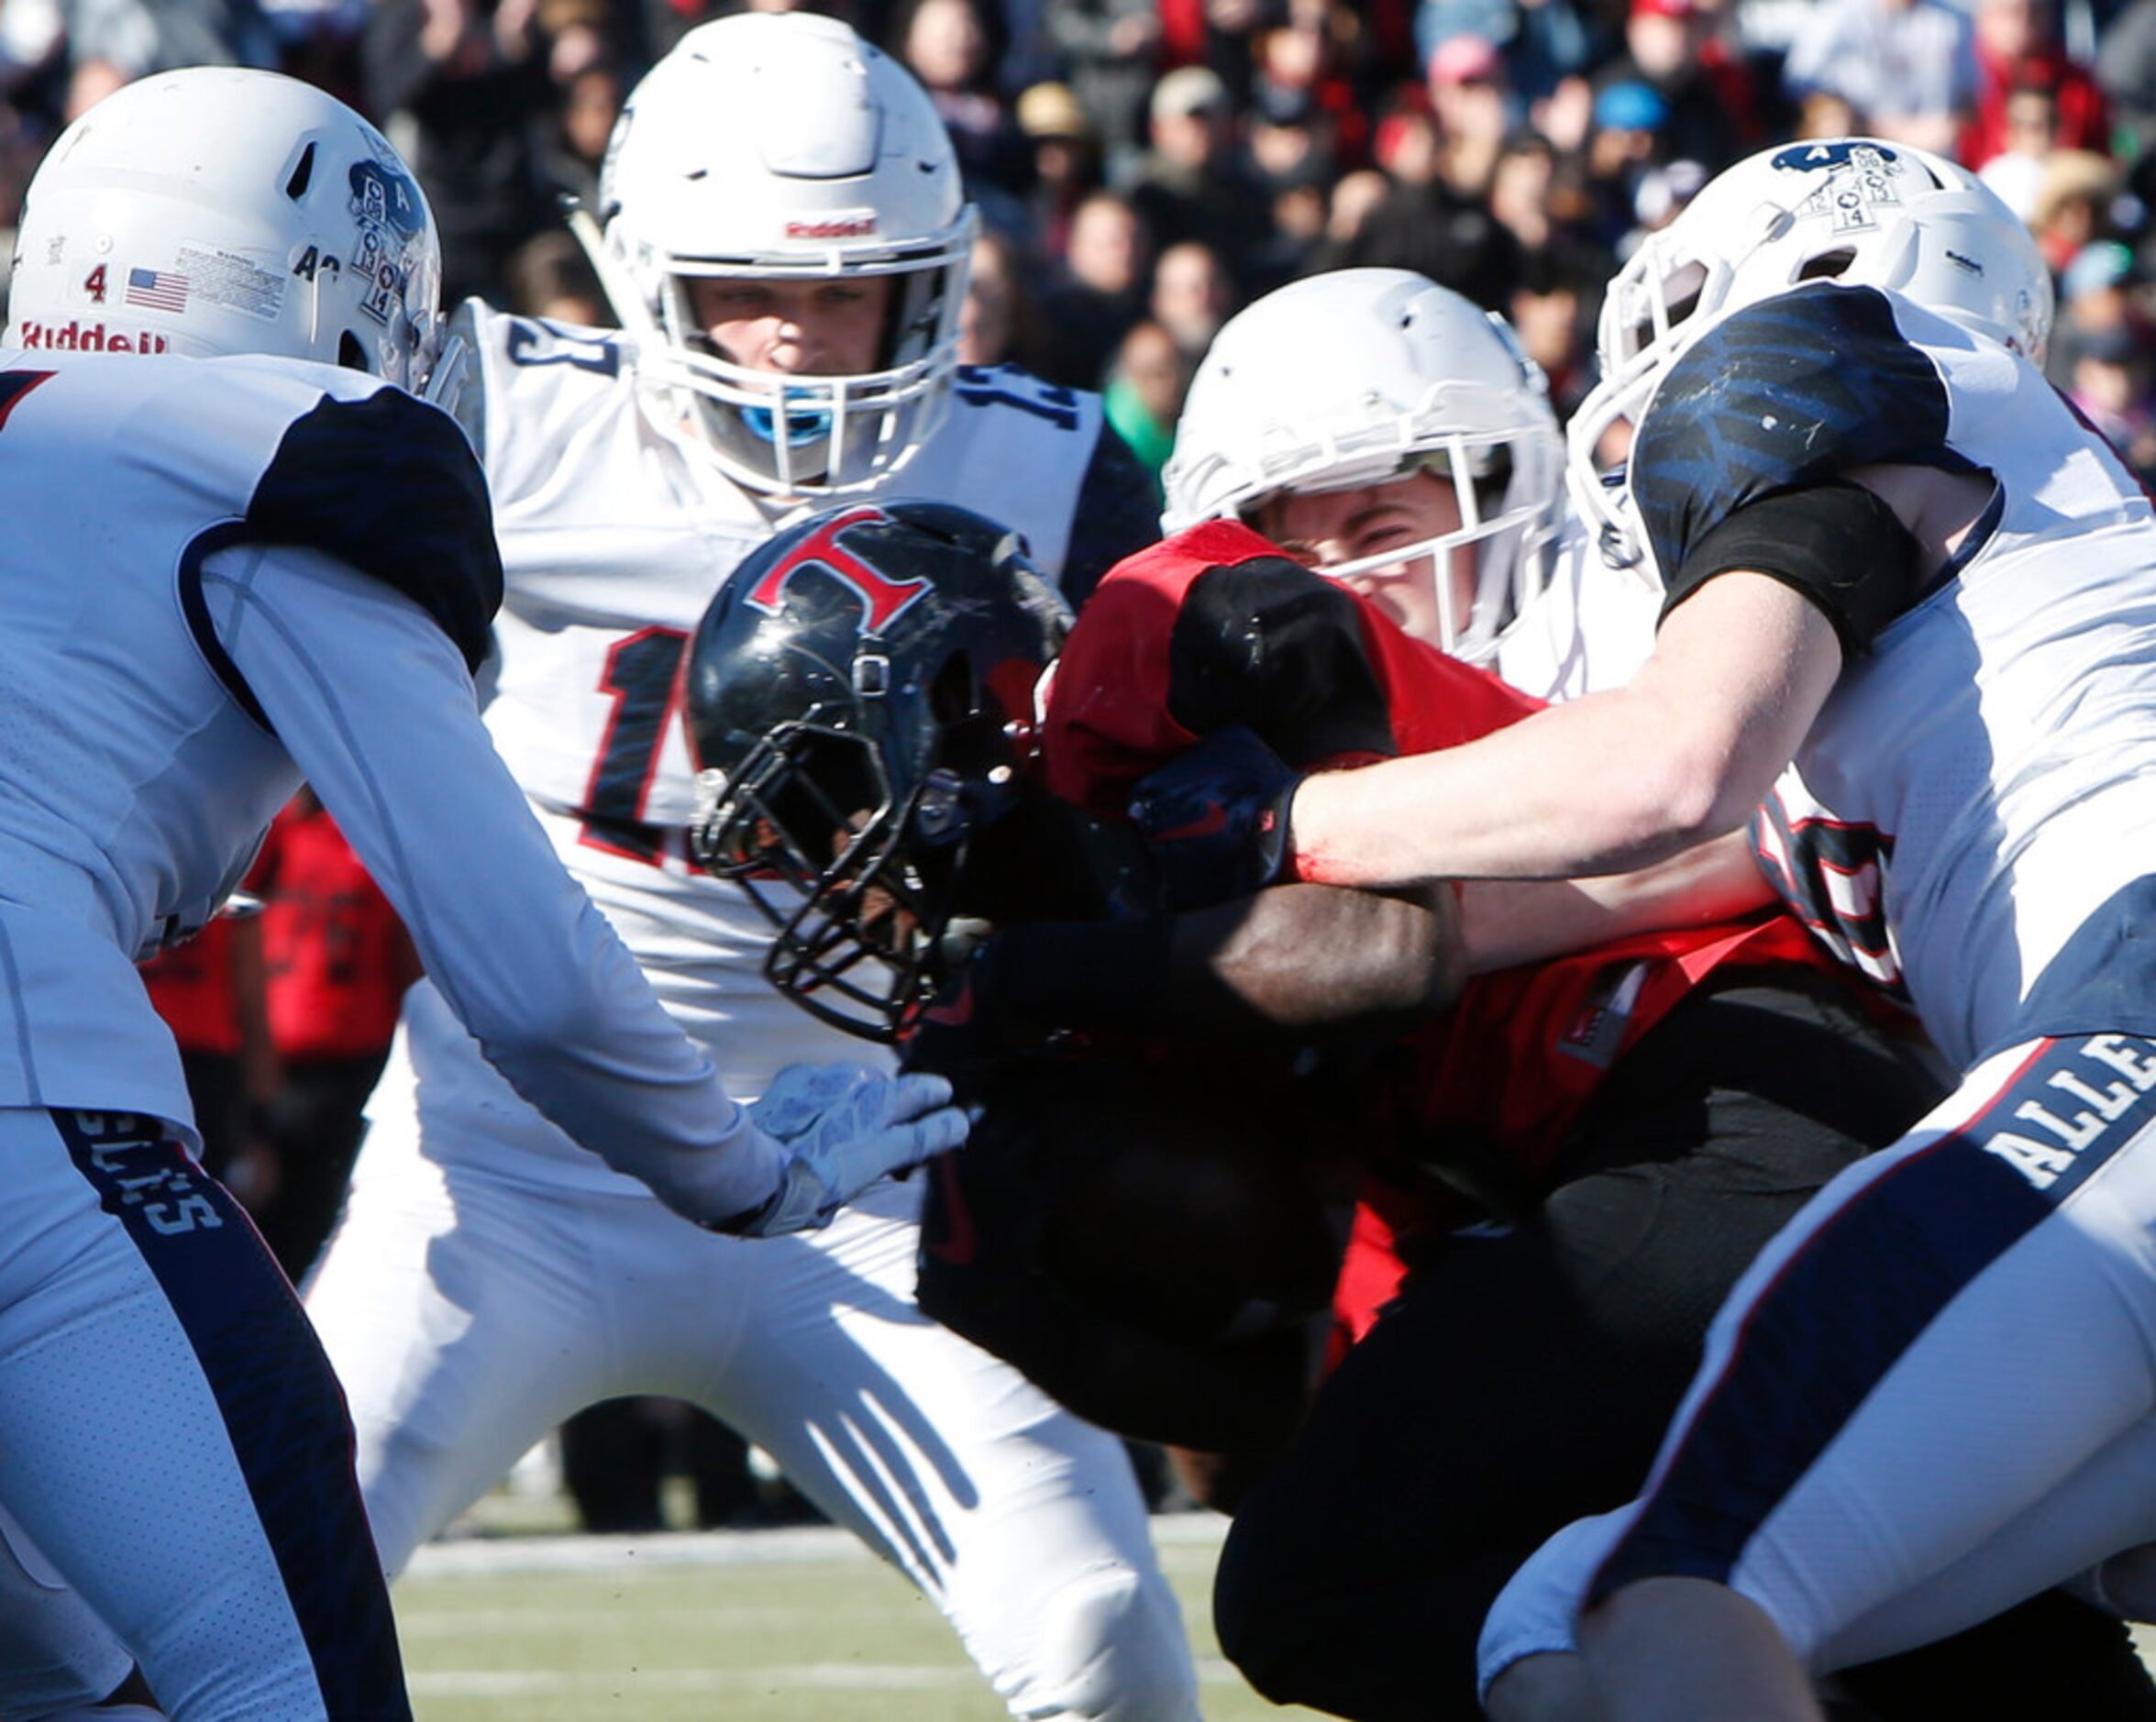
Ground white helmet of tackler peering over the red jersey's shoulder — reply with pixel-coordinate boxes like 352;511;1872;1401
1162;270;1565;662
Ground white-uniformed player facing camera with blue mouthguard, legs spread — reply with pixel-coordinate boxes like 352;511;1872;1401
295;13;1197;1717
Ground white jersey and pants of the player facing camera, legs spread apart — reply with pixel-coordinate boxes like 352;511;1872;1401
308;306;1194;1717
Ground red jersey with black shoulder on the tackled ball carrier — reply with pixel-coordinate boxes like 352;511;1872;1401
1044;522;1826;1339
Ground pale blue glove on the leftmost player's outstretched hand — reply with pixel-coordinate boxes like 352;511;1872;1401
718;1065;966;1237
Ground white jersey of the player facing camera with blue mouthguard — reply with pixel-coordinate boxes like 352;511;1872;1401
405;300;1149;1183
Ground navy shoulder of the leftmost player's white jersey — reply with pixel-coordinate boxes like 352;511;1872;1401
244;386;503;670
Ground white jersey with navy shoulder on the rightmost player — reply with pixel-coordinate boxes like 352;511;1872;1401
1632;289;2156;1065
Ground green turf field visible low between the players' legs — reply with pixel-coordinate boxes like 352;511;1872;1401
397;1515;1313;1722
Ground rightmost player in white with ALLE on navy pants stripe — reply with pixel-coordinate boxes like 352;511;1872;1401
1171;138;2156;1717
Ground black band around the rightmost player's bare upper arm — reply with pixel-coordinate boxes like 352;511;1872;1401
1663;482;1921;656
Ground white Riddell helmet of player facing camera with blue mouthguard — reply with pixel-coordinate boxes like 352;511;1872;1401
597;13;975;496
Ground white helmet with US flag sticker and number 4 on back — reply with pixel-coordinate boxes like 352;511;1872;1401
0;67;442;392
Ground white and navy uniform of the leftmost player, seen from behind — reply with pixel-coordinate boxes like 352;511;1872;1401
0;353;779;1722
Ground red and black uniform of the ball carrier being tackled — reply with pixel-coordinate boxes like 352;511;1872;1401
1045;524;2086;1720
